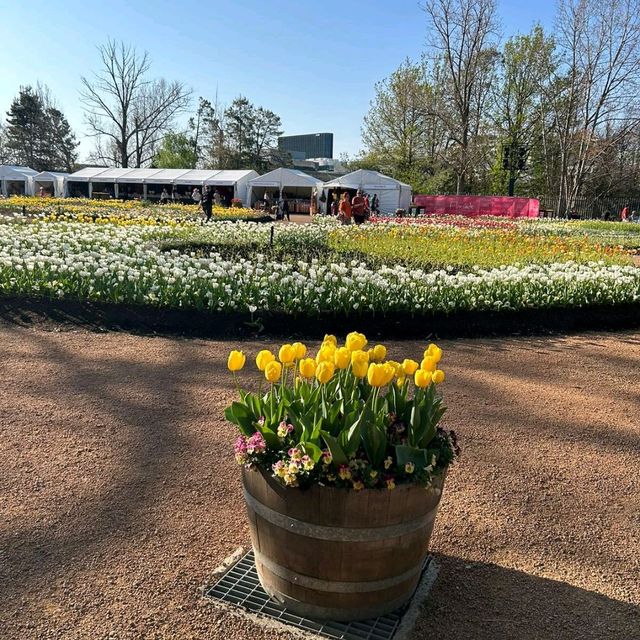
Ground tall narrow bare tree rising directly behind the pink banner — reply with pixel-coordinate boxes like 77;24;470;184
423;0;497;194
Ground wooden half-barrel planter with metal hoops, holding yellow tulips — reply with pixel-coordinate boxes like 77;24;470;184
243;469;444;621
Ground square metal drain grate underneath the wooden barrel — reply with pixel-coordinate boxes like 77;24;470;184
205;551;431;640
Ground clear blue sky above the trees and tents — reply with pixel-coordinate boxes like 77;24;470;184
0;0;555;159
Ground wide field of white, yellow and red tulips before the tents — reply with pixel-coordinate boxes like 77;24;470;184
0;198;640;324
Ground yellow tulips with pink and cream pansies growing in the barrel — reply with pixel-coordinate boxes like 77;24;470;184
225;332;459;491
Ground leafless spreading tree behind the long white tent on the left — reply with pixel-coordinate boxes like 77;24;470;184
80;40;191;167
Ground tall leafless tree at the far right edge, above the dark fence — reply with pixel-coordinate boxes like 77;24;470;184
545;0;640;214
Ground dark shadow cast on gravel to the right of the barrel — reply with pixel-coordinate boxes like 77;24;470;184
410;555;640;640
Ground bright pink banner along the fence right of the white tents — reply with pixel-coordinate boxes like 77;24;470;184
413;196;540;218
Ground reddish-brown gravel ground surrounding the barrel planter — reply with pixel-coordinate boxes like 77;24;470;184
0;325;640;640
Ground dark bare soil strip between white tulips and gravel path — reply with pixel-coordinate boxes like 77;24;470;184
0;297;640;339
